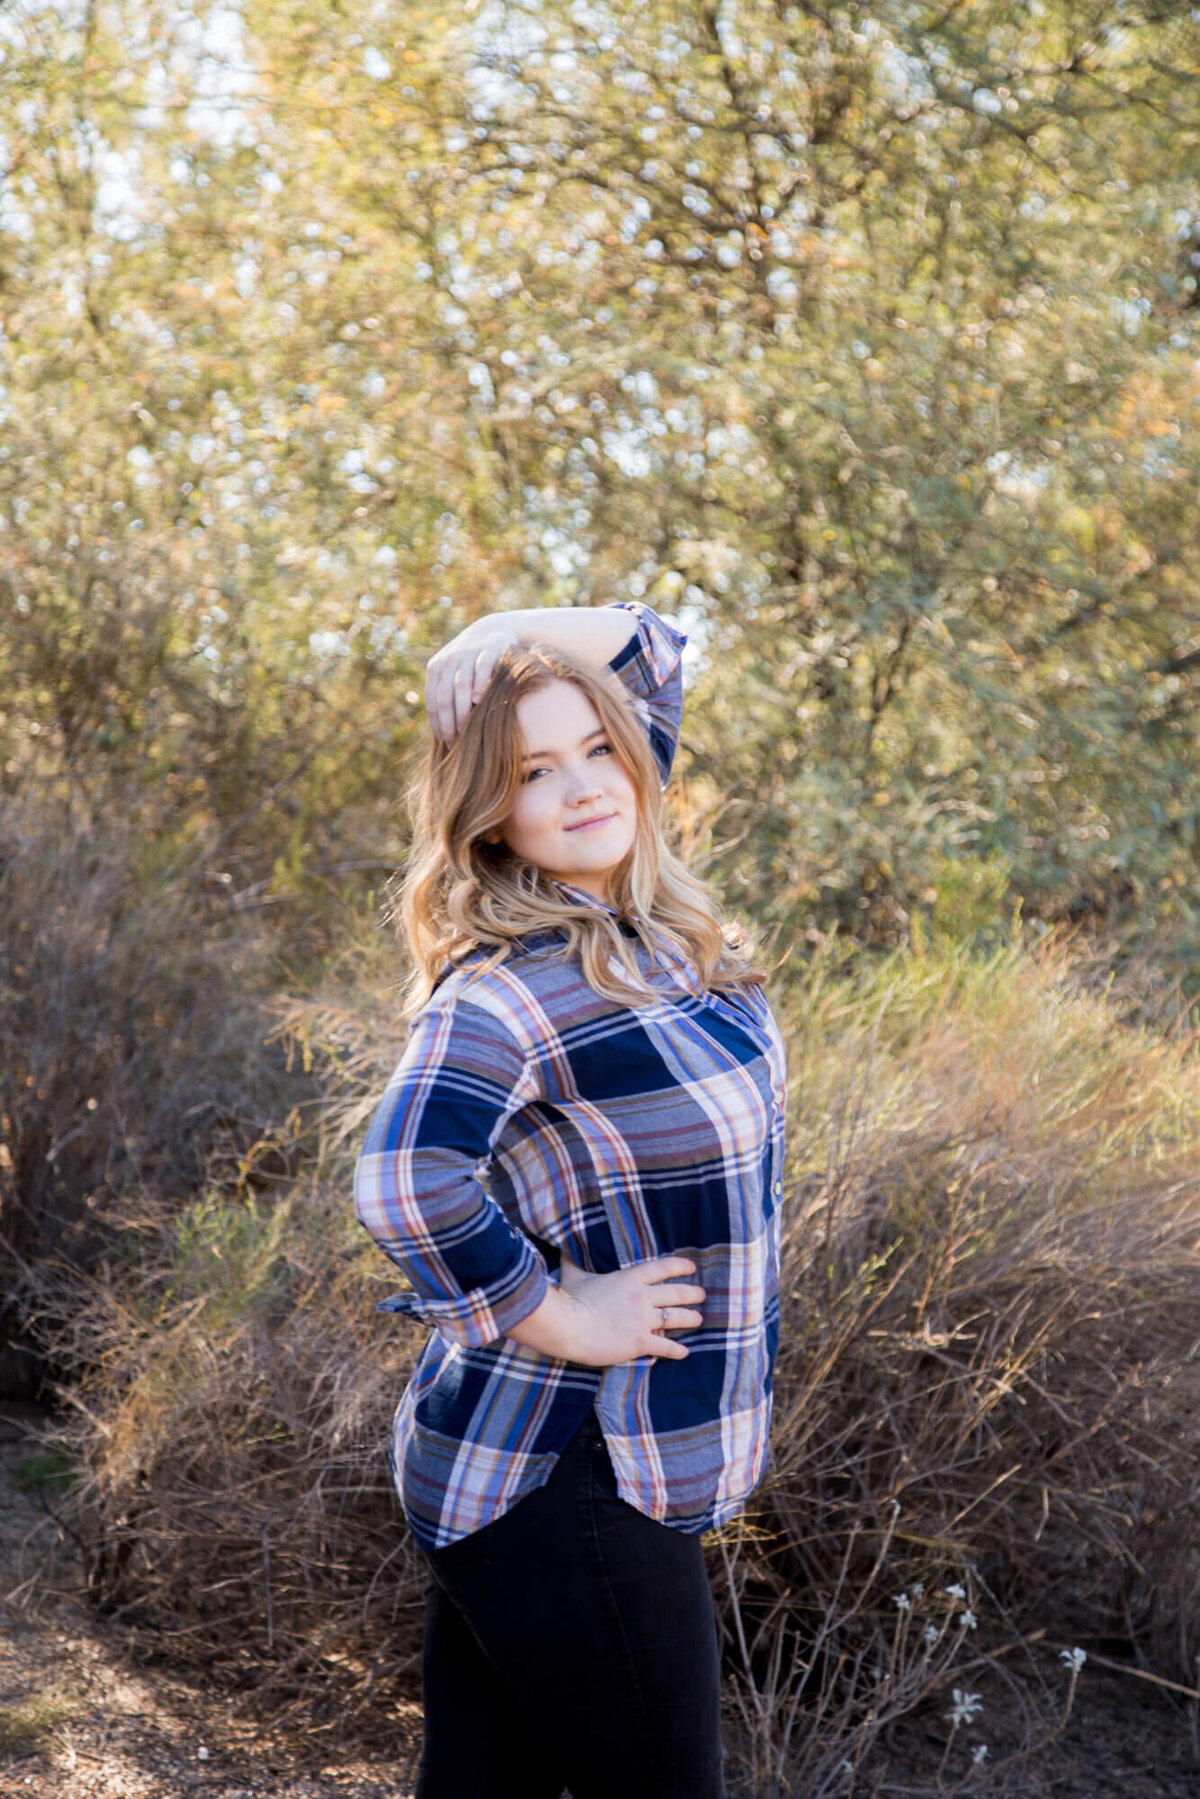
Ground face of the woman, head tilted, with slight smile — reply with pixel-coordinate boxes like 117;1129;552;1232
498;680;637;901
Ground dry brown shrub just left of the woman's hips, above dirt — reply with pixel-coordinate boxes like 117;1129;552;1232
26;1180;431;1738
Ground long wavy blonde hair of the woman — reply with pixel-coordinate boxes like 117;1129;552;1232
390;644;766;1018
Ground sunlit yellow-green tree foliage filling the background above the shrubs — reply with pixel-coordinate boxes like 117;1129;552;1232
0;0;1200;979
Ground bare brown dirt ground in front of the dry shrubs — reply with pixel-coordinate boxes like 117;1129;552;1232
0;1405;1200;1799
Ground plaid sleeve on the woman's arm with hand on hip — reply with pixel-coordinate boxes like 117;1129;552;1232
354;998;549;1346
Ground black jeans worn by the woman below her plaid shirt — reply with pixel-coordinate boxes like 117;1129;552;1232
416;1412;725;1799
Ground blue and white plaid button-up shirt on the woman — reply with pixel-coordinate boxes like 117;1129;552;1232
354;601;786;1549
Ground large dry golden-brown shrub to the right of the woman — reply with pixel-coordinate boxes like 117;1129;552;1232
714;943;1200;1799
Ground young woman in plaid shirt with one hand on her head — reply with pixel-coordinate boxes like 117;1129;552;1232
354;601;786;1799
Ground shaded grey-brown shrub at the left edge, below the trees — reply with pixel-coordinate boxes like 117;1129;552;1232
0;811;309;1392
